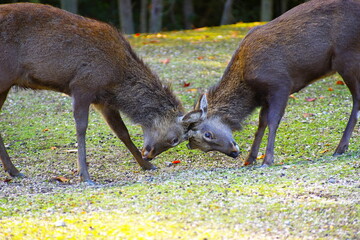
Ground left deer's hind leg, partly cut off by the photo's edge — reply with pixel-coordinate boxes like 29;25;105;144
0;89;24;177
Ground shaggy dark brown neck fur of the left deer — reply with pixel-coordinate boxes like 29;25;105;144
109;35;184;127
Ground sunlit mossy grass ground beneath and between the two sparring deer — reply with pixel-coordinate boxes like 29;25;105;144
0;23;360;239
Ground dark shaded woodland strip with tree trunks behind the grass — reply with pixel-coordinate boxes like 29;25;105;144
0;0;304;34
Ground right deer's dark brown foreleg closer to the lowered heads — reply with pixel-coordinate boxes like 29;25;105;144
244;105;268;166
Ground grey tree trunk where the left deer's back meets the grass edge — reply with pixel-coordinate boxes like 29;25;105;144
118;0;135;34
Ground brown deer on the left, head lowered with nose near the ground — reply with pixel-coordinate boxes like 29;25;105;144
0;3;200;184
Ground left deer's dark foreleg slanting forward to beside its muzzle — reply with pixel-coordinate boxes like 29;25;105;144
95;104;156;170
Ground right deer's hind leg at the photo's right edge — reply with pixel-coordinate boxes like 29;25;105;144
334;65;360;156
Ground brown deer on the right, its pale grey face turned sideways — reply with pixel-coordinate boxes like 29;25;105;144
188;0;360;166
